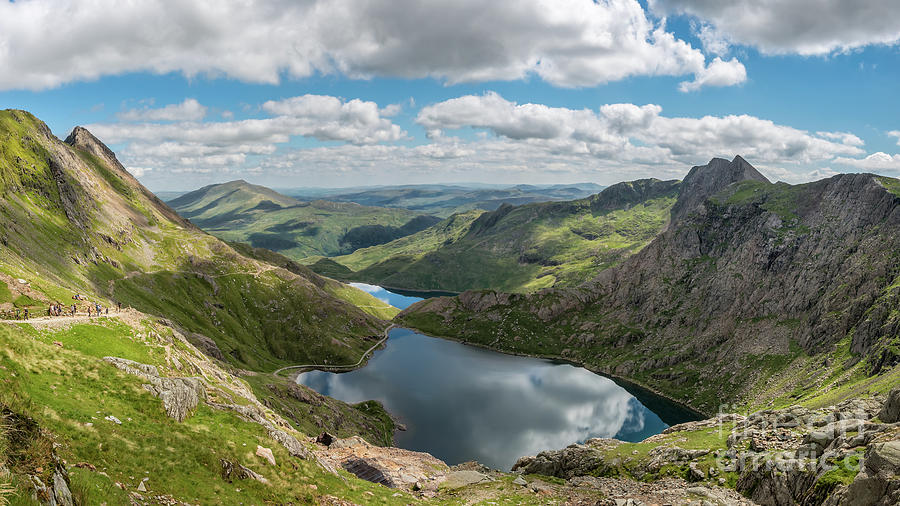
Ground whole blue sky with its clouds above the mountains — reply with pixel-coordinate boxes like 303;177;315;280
0;0;900;190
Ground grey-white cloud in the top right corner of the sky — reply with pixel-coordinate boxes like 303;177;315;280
649;0;900;55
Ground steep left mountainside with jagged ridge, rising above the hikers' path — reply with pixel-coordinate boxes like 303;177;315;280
0;111;391;370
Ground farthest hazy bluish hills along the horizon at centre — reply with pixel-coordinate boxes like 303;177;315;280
283;183;603;218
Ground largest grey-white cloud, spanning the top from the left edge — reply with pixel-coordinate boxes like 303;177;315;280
0;0;740;89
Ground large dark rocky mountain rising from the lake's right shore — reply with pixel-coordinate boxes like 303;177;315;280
398;158;900;413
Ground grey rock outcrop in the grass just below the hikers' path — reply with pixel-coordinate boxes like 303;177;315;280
104;357;206;422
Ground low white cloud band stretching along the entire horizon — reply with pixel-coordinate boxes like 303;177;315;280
88;92;890;186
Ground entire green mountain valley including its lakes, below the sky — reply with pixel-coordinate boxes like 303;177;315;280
0;110;900;504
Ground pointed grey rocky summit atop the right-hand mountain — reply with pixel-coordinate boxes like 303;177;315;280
672;155;770;221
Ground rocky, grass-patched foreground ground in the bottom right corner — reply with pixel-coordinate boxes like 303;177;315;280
513;398;900;506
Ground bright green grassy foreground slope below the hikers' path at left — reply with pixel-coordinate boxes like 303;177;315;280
0;318;408;505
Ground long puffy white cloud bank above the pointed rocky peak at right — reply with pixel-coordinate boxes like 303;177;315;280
416;93;864;164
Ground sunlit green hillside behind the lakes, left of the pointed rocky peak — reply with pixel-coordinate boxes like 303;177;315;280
312;180;678;292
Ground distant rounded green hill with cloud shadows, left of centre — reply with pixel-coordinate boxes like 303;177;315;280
169;181;438;260
